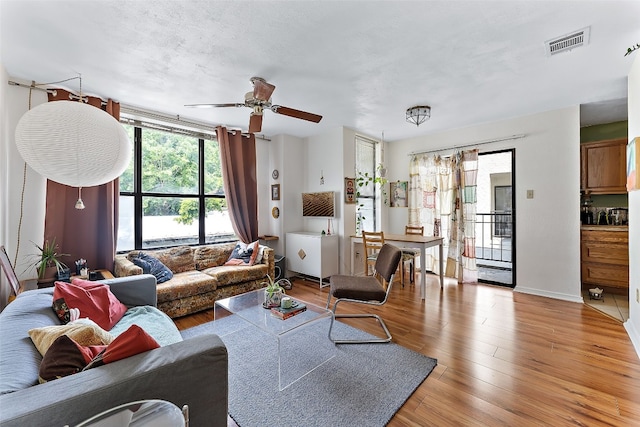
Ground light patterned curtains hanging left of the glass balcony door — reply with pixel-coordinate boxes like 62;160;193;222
409;150;478;282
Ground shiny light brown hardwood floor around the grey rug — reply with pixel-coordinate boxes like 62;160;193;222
176;276;640;426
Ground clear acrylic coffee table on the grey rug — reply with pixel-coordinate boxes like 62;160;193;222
213;289;336;391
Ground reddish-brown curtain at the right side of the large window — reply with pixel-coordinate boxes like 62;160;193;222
216;126;258;243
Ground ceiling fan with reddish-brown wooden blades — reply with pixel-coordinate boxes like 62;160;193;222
185;77;322;133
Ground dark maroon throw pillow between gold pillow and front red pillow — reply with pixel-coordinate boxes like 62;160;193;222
38;335;105;384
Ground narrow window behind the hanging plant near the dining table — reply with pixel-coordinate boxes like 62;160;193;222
356;135;379;231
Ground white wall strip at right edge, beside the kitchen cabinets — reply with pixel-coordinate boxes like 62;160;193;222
624;53;640;356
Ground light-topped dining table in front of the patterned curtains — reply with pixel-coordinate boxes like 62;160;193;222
351;233;444;300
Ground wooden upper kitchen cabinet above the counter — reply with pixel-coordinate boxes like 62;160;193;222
580;138;627;194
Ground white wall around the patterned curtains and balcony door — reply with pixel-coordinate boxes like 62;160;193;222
386;106;582;302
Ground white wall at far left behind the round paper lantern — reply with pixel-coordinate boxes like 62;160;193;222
0;72;47;280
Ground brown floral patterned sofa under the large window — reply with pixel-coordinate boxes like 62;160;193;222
114;243;275;318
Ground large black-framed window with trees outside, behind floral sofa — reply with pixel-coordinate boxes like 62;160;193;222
117;125;236;251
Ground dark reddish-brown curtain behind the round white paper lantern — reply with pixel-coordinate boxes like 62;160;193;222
44;89;120;273
